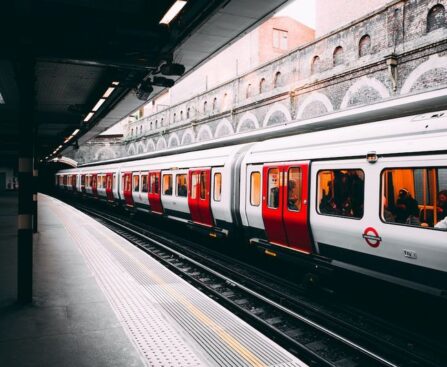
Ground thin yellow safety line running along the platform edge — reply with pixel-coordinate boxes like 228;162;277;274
57;203;267;367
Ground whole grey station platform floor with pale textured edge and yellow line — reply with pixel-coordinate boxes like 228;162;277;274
0;195;304;367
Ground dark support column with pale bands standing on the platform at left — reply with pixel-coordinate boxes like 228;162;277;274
16;56;34;303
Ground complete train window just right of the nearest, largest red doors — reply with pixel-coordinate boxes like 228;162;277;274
318;169;365;219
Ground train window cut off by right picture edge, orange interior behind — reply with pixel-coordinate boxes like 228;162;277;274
380;167;447;229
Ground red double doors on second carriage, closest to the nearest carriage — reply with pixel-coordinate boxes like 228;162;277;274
188;168;214;226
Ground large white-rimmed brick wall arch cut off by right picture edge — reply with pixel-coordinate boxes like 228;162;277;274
400;54;447;95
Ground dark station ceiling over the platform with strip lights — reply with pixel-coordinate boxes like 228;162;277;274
0;0;288;165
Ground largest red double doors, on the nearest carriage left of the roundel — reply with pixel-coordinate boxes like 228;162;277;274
262;162;312;253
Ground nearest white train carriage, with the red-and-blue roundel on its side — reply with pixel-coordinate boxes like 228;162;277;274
241;113;447;295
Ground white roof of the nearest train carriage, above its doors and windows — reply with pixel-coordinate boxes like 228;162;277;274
245;111;447;164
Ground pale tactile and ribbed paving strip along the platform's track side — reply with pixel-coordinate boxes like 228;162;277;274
49;197;304;367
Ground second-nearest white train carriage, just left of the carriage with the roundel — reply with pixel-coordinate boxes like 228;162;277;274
120;144;250;236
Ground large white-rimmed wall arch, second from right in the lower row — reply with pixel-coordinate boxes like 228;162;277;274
340;76;390;110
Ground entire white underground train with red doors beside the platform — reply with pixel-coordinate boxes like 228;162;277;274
56;111;447;297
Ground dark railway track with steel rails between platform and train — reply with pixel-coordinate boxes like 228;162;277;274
70;203;446;366
